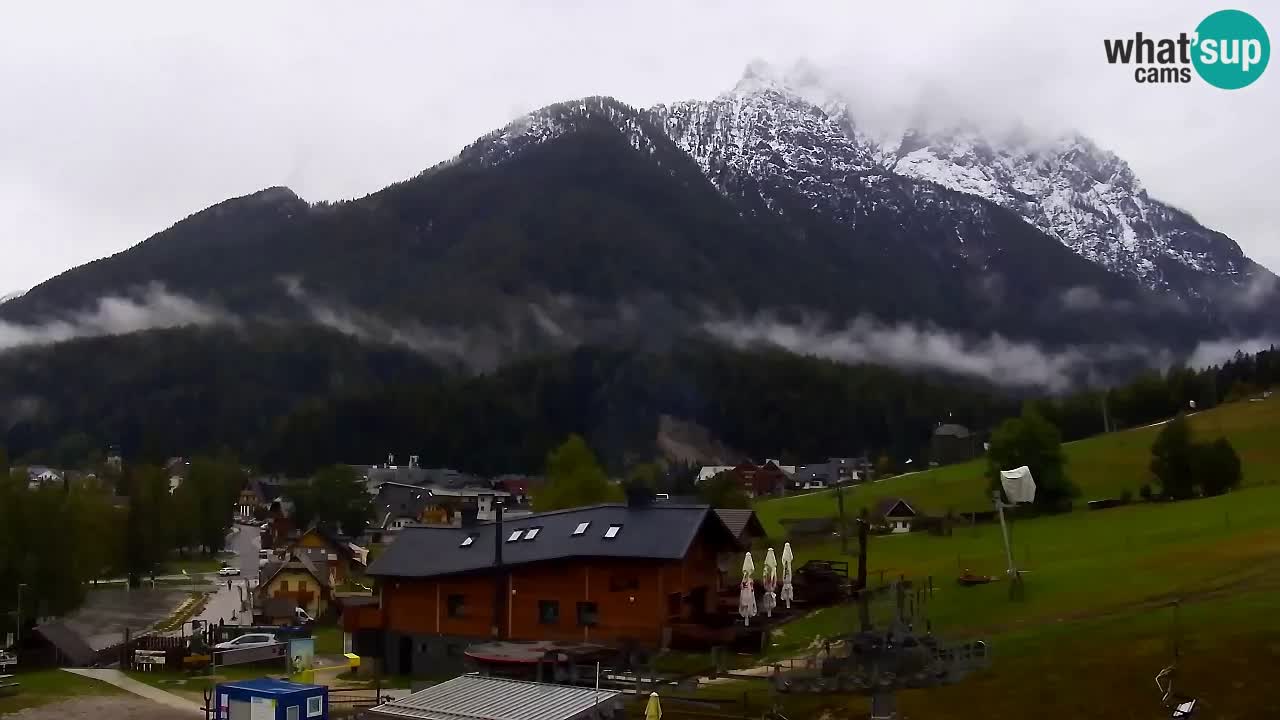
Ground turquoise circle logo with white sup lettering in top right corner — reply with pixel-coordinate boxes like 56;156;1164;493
1192;10;1271;90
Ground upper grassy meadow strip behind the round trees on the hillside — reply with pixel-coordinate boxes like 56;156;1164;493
755;398;1280;537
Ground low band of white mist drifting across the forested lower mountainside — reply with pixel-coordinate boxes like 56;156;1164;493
0;278;1280;392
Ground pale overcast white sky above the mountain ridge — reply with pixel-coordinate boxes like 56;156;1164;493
0;0;1280;295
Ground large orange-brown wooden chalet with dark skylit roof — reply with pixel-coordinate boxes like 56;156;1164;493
344;503;759;674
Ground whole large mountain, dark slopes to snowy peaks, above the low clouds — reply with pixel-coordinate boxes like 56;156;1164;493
0;64;1274;368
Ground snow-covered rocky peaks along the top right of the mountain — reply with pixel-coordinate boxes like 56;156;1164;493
652;60;1256;302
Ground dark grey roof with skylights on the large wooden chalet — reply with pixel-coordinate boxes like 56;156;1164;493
369;503;732;578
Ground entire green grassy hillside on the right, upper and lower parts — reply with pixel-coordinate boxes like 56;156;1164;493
732;401;1280;720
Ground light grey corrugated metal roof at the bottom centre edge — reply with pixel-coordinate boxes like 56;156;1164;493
371;675;622;720
